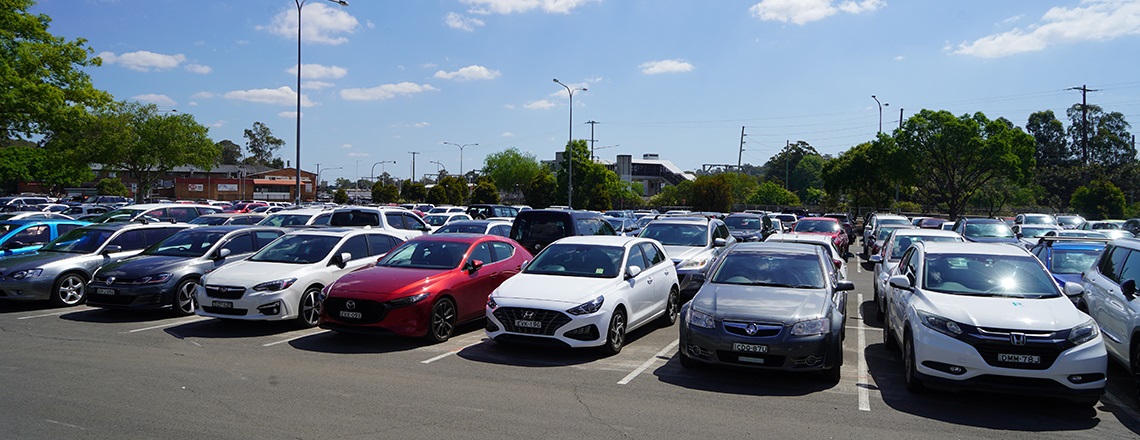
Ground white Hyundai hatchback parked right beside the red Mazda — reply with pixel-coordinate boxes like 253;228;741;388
487;236;681;355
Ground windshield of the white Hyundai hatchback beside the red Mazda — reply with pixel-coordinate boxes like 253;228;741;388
523;243;625;278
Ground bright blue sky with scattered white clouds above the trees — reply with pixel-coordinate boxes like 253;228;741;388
32;0;1140;180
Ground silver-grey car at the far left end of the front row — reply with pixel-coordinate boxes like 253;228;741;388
0;223;190;305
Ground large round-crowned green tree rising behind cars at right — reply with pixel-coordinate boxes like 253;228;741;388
896;109;1036;219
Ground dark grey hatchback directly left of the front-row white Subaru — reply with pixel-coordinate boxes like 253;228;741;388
87;225;285;316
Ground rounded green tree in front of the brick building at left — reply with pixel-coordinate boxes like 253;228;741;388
77;101;220;201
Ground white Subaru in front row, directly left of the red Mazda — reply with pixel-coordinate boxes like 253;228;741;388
194;228;405;327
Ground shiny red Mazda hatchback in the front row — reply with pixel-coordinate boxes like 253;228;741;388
319;234;530;342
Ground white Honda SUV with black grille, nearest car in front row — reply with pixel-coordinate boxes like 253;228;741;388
884;243;1108;405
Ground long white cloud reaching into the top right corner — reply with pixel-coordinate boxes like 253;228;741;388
953;0;1140;58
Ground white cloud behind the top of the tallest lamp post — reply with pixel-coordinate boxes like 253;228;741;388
257;2;360;44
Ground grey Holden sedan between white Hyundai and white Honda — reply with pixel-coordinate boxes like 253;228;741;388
678;242;855;382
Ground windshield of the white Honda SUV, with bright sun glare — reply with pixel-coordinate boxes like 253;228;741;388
922;254;1060;298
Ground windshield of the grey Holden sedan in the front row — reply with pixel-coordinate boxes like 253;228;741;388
711;252;824;288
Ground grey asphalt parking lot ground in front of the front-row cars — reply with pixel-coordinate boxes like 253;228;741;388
0;249;1140;439
